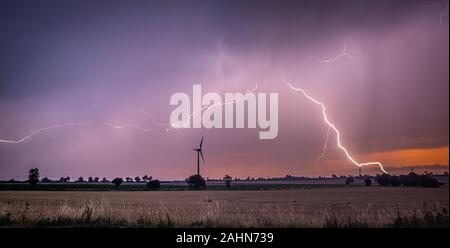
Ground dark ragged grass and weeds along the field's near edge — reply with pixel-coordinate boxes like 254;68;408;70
0;201;449;228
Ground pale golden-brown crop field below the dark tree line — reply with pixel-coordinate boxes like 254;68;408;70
0;186;449;227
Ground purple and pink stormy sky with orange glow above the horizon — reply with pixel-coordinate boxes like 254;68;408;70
0;0;449;179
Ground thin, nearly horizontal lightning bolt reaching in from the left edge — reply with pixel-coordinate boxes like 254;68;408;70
0;122;152;144
